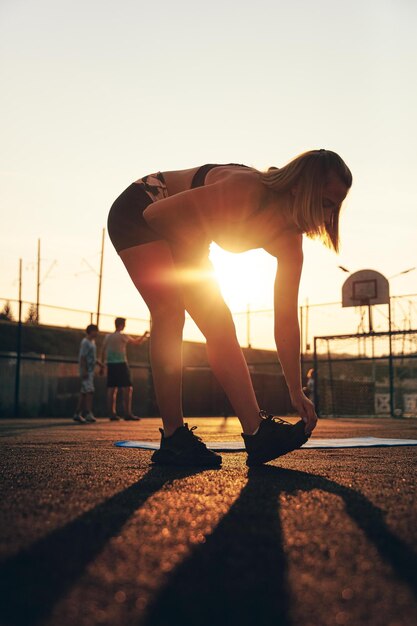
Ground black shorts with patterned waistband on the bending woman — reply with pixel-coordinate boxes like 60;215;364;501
107;172;168;252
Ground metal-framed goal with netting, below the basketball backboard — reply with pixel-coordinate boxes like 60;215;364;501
313;330;417;417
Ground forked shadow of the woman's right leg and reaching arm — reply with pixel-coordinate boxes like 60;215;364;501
141;466;417;626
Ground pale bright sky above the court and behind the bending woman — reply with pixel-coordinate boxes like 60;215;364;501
0;0;417;346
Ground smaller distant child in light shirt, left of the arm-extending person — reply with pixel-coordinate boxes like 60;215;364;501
73;324;103;424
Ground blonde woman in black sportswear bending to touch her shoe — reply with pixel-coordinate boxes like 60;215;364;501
108;149;352;466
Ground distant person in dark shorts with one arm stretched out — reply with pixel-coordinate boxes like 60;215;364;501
102;317;149;422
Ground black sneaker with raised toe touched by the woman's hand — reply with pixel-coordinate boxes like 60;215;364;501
242;411;308;467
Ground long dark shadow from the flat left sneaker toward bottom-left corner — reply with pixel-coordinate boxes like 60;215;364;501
0;468;203;626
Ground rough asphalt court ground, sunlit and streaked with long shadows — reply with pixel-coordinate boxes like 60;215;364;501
0;418;417;626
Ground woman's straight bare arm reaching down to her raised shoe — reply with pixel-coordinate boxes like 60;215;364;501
268;234;317;433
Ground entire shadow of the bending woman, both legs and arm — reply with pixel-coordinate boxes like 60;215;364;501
0;466;417;626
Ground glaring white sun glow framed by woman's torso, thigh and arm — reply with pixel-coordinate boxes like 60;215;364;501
210;244;276;312
